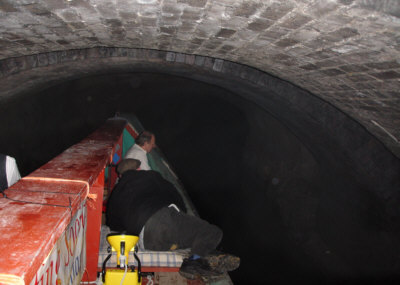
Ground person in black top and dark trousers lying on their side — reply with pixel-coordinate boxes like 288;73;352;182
106;159;240;279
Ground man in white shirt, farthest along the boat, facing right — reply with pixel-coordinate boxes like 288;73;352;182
124;131;156;170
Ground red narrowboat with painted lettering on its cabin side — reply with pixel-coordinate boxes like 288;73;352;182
0;115;232;285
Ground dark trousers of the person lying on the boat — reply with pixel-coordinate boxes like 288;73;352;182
143;204;222;256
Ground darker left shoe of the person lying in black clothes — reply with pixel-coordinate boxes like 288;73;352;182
179;258;225;280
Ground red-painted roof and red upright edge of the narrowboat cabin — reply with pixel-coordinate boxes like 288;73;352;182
0;117;126;284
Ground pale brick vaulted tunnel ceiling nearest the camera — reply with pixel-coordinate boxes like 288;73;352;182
0;0;400;157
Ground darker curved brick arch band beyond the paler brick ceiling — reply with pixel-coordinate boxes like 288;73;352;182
0;47;396;186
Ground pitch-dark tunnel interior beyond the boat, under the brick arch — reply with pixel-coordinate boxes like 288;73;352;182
0;73;400;284
